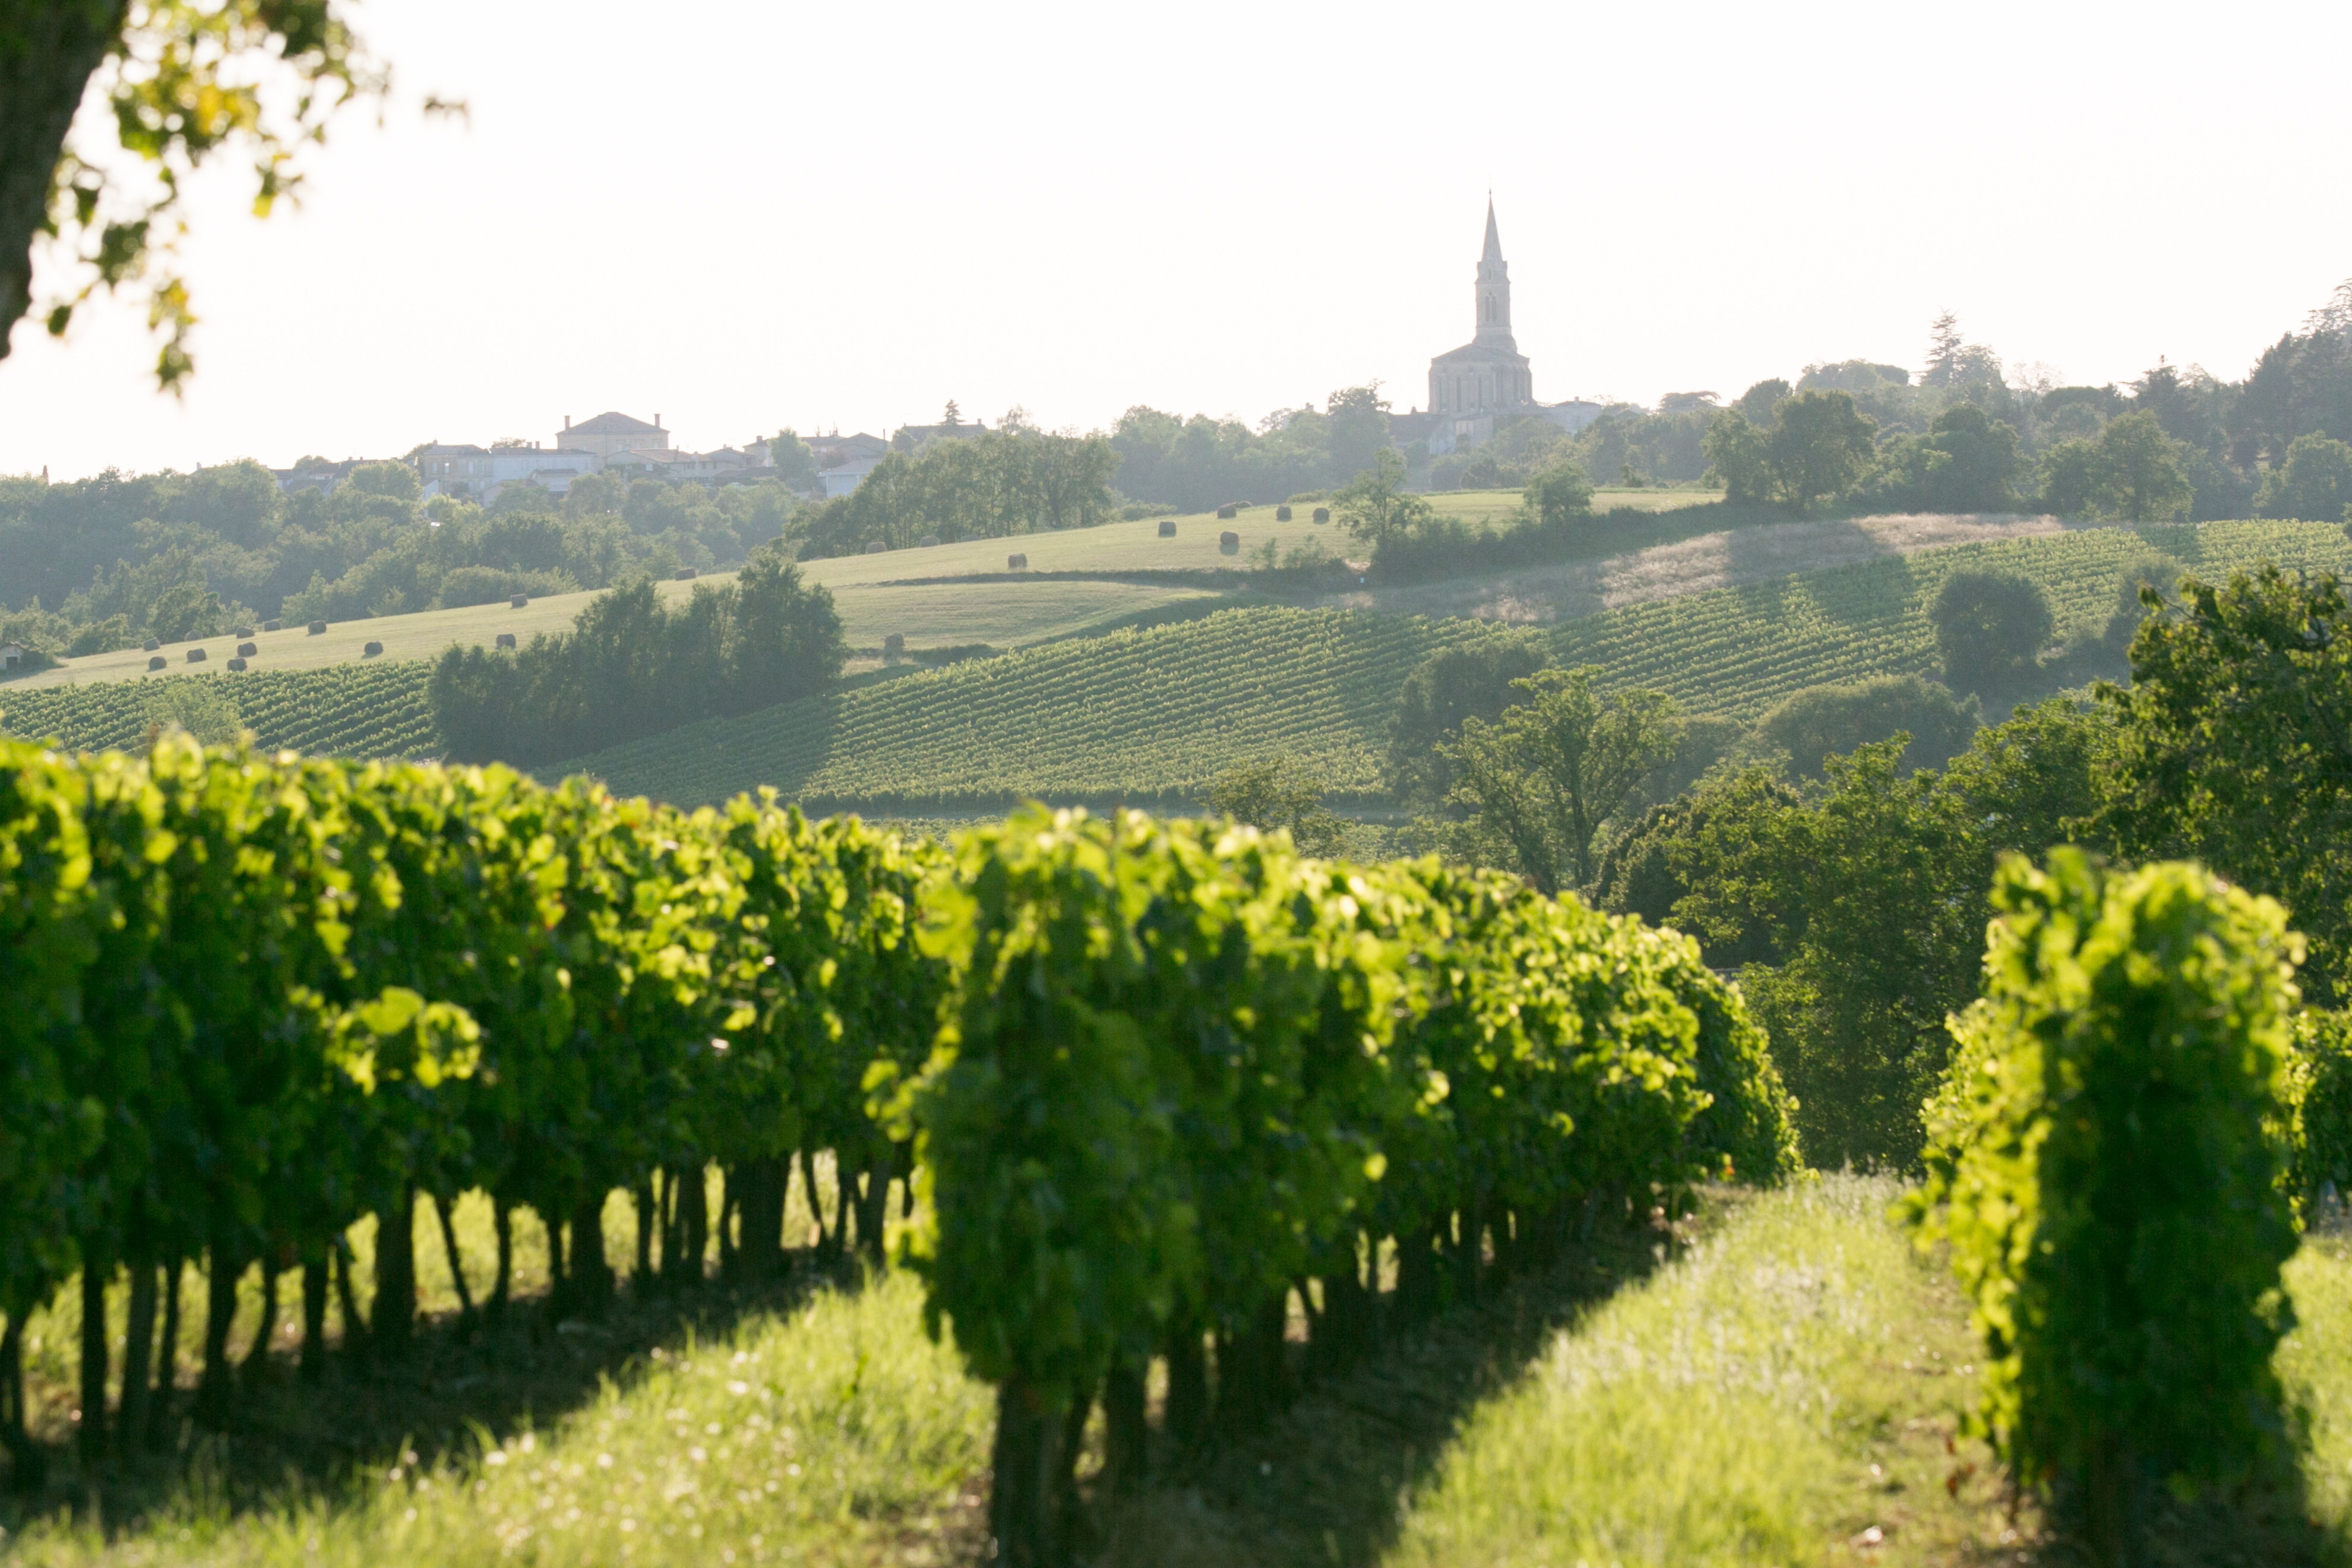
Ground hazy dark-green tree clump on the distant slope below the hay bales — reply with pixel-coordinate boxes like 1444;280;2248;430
428;545;847;766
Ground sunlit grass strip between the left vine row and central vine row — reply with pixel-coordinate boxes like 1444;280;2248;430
10;1274;992;1568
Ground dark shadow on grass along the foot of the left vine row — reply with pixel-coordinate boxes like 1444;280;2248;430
0;1251;858;1533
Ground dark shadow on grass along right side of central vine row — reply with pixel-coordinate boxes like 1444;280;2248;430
1091;1218;1684;1568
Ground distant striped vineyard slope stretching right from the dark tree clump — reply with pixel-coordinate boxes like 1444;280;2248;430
564;522;2352;811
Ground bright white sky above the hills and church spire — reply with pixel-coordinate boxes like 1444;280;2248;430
0;0;2352;477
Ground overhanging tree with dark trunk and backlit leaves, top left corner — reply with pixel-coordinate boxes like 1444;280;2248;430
0;0;390;390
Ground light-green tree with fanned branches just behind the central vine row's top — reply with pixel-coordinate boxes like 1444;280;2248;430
1441;665;1675;893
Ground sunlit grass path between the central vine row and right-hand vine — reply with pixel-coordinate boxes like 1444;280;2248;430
1390;1175;1999;1568
